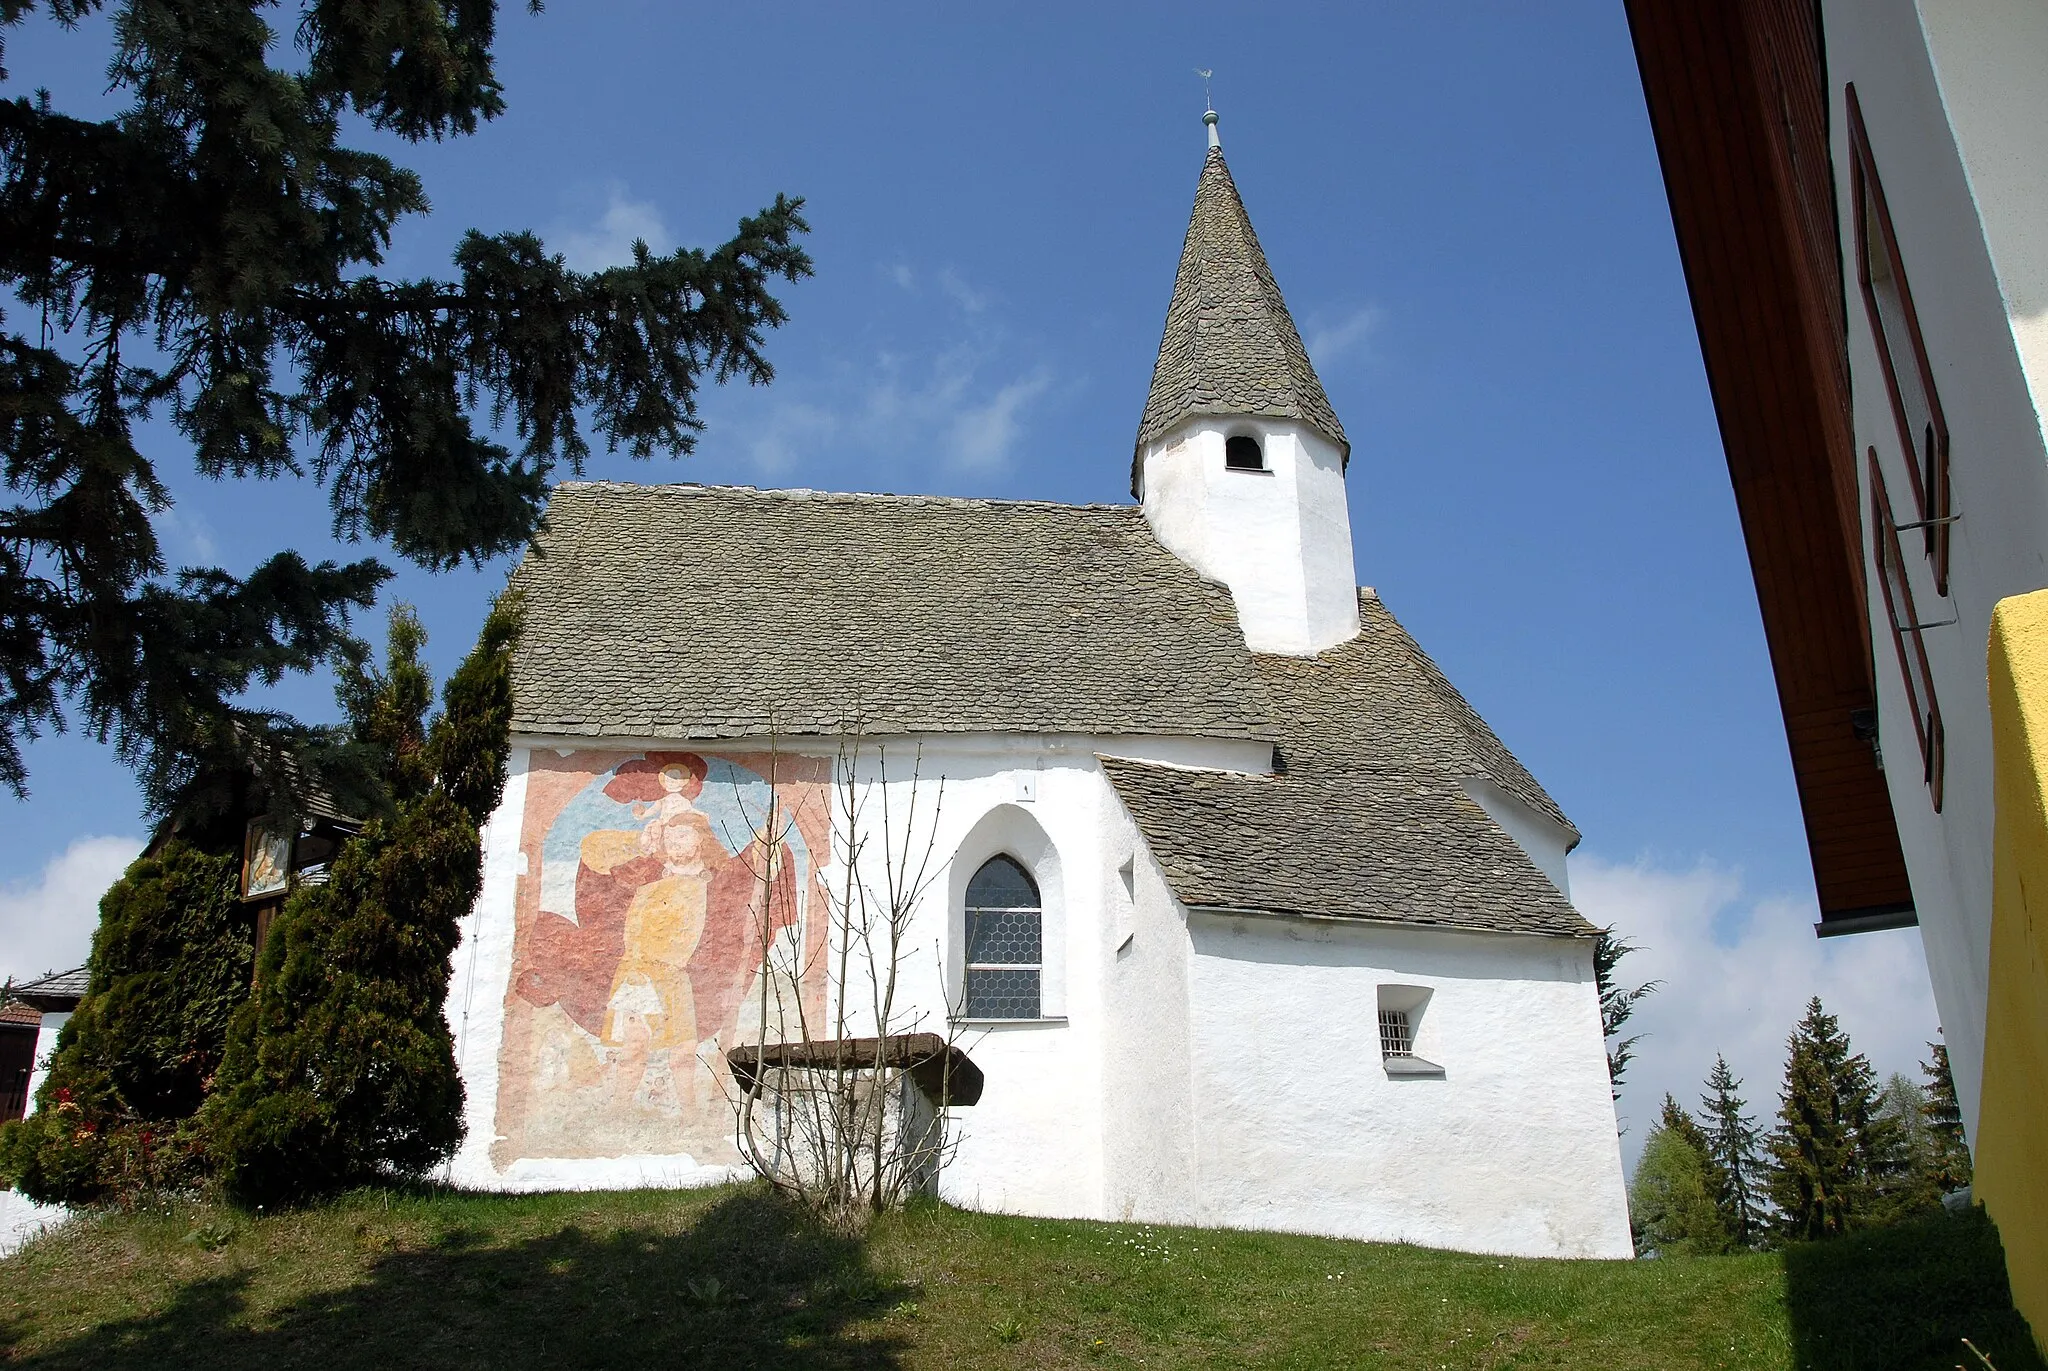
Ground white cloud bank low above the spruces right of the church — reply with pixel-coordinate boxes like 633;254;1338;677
1571;855;1937;1168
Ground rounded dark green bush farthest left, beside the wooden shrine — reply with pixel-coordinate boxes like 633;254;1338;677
0;838;254;1205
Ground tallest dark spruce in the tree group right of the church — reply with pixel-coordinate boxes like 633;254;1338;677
1765;996;1876;1242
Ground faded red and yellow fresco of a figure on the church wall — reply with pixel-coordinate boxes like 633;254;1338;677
492;750;831;1168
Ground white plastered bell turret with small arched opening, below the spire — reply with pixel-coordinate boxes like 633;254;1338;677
1139;418;1358;656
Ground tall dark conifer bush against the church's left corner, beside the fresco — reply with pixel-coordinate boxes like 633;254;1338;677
207;600;518;1203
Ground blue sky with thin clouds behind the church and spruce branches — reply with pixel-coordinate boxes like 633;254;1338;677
0;0;1933;1133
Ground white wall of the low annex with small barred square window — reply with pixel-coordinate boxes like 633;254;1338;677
1190;912;1632;1258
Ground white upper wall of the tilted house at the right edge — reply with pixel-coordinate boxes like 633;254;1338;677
1825;0;2048;1135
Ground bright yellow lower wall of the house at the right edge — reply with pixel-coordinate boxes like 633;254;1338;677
1974;590;2048;1338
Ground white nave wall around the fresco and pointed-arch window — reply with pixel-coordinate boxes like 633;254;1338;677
446;736;1272;1217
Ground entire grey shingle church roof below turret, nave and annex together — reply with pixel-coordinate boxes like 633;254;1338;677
512;484;1591;937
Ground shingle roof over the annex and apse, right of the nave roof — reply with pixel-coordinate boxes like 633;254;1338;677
1102;590;1595;937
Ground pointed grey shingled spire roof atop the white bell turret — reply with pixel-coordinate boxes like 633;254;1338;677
1130;146;1352;496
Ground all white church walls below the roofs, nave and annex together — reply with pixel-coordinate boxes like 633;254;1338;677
449;736;1628;1256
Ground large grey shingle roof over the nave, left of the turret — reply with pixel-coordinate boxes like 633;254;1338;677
512;484;1272;738
